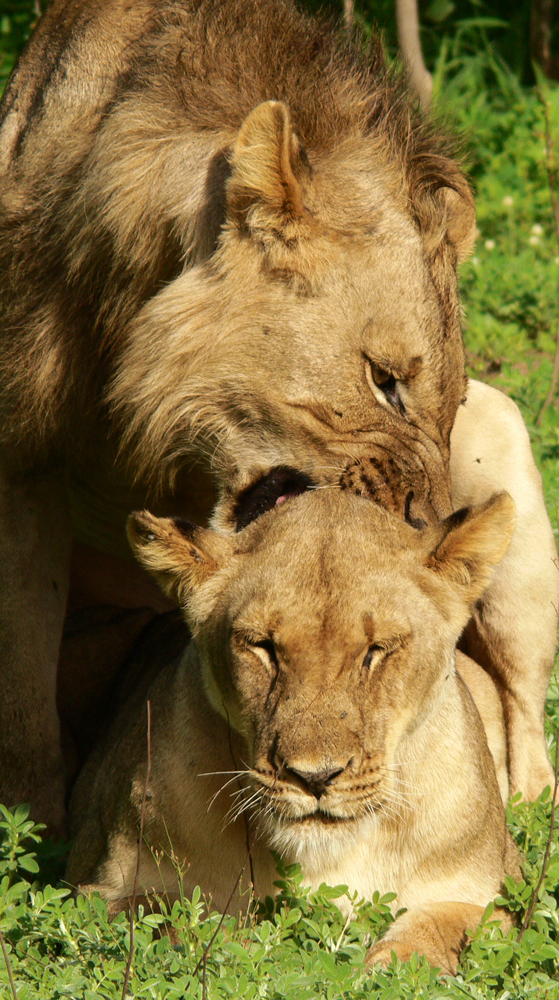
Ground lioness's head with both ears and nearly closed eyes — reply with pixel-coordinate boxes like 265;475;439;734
128;490;515;856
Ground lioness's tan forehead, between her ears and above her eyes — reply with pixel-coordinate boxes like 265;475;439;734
220;489;429;645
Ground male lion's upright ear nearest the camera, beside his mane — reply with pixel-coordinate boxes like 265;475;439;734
227;101;309;228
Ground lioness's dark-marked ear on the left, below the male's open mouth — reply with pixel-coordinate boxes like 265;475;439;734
126;510;228;604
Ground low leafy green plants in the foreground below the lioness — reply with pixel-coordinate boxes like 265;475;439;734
0;790;559;1000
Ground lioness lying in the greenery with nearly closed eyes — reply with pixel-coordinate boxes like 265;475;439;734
67;490;519;972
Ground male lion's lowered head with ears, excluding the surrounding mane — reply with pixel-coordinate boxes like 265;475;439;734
110;94;474;504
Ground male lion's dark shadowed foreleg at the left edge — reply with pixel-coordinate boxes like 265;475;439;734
0;462;71;834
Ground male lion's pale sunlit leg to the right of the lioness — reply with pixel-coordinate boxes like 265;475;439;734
450;380;559;799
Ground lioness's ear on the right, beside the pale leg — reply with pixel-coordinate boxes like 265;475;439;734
426;493;516;605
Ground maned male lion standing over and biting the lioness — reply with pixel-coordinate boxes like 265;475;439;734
0;0;559;831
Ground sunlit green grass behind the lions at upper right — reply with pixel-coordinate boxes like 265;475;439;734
437;60;559;531
